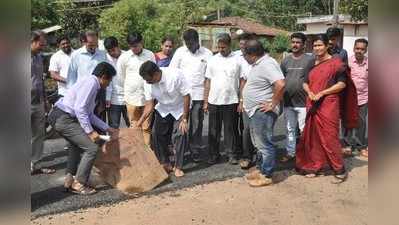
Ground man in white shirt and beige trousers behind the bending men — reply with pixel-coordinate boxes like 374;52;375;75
117;33;155;146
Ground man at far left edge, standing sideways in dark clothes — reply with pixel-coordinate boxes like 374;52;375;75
30;31;55;174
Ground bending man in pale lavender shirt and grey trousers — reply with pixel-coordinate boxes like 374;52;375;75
49;62;117;194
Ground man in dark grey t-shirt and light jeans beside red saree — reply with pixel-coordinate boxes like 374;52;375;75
281;33;314;162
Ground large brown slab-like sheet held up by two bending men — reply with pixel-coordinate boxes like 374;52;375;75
95;128;168;193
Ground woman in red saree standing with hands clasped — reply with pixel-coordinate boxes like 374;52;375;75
296;34;357;183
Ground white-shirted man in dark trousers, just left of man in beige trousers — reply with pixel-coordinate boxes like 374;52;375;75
104;36;130;129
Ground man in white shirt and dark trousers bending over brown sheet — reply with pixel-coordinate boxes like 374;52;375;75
137;61;190;177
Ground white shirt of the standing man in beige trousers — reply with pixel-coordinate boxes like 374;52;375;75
117;49;155;106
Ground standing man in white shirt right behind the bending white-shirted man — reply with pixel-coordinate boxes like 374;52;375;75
169;29;212;162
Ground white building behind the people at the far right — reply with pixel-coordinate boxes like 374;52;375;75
297;14;368;55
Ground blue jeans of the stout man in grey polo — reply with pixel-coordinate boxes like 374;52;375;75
249;110;277;177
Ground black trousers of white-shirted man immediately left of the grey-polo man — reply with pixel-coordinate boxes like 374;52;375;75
208;104;238;157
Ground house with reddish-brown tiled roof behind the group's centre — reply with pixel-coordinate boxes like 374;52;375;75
188;17;289;52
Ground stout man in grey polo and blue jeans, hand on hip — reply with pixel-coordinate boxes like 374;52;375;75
243;40;285;187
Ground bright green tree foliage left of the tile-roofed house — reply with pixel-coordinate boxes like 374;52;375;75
99;0;214;51
